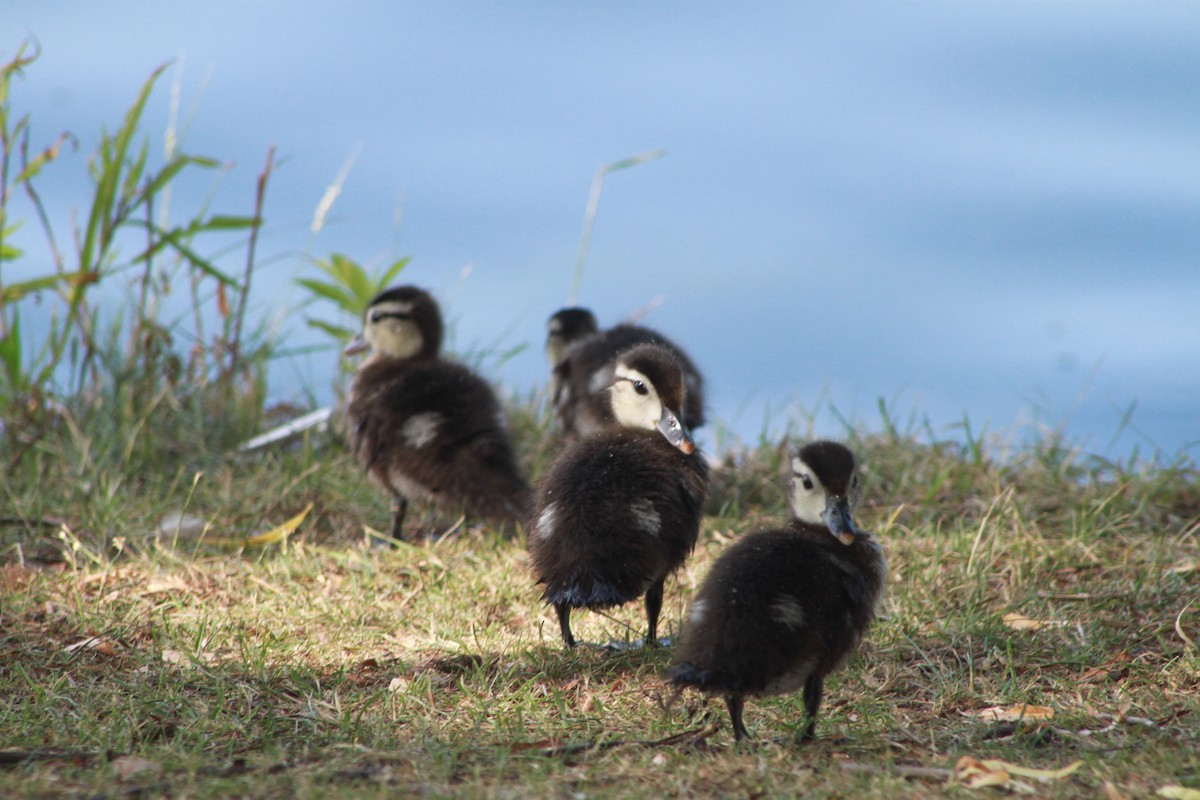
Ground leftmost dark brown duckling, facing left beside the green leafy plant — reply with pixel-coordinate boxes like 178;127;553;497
344;285;533;539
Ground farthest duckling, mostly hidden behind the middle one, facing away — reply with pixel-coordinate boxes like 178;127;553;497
546;307;704;440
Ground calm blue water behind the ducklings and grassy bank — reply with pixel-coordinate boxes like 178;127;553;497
0;0;1200;458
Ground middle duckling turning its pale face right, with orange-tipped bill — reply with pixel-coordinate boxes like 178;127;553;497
529;344;709;648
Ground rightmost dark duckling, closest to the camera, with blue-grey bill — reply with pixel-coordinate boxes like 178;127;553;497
671;441;888;740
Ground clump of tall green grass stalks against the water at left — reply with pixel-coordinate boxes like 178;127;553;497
0;47;275;458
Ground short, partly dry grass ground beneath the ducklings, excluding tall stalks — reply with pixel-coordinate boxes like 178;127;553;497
0;408;1200;798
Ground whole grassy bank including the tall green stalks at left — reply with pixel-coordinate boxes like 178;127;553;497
0;47;1200;800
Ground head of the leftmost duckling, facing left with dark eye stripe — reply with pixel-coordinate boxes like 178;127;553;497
343;287;442;359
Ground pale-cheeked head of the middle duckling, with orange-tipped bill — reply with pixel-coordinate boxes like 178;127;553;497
608;344;696;453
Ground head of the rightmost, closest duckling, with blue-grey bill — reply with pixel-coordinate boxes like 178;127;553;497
788;441;860;545
